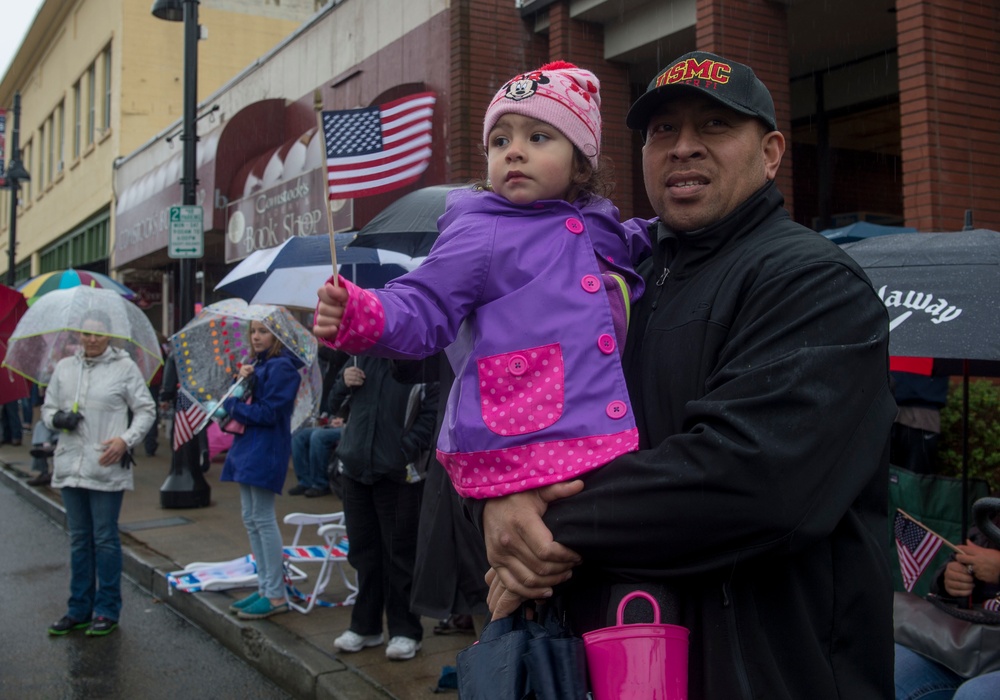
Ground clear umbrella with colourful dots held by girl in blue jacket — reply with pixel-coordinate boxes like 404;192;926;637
170;299;323;430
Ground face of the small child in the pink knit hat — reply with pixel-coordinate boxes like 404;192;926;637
487;114;573;204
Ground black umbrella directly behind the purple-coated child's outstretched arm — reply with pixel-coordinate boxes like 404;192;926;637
349;185;467;258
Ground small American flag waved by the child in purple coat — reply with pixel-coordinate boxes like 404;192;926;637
323;92;437;199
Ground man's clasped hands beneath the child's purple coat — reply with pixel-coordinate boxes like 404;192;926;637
483;480;583;617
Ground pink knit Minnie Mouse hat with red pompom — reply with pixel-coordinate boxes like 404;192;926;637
483;61;601;168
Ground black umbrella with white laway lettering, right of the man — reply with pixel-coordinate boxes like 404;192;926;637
841;229;1000;537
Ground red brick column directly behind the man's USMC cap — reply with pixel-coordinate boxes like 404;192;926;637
695;0;794;216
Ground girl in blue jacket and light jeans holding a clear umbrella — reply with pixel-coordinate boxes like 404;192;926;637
222;321;302;620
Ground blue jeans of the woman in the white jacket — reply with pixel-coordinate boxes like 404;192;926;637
62;487;125;621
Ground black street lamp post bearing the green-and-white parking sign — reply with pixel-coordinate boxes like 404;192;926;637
152;0;211;508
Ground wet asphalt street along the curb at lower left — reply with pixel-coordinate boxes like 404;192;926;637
0;484;290;700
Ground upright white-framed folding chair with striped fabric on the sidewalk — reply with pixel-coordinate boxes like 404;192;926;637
283;512;358;613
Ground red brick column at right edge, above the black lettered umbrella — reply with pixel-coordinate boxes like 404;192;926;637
896;0;1000;231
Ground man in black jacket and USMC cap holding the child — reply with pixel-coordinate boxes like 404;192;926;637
478;52;896;700
